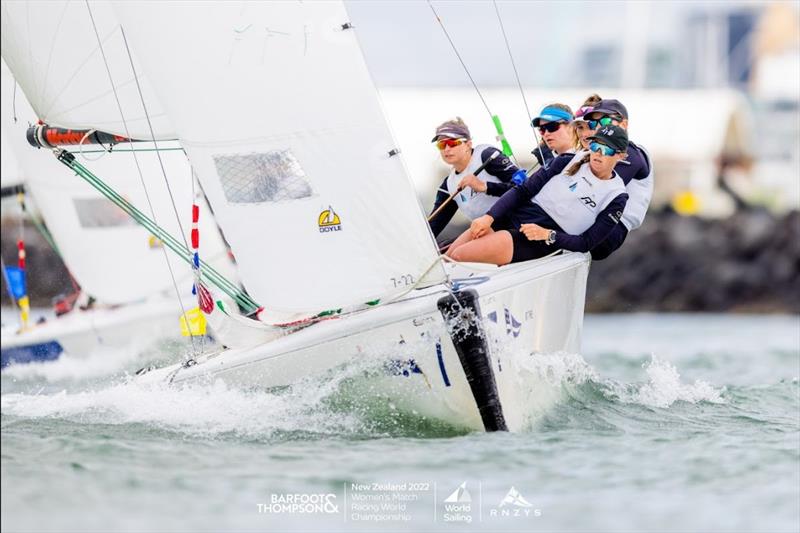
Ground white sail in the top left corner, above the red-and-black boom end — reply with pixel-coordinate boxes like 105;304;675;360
0;0;175;140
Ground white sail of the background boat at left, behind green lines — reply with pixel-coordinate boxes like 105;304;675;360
0;58;234;311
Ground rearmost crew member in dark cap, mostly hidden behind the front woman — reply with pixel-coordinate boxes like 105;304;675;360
584;99;653;260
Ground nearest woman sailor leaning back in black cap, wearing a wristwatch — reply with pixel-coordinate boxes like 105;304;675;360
447;126;628;265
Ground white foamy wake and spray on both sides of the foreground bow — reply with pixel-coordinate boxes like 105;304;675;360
2;338;726;442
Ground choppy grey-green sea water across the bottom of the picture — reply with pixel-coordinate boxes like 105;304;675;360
1;314;800;532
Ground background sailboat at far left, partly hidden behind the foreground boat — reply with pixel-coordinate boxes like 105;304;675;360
0;45;235;367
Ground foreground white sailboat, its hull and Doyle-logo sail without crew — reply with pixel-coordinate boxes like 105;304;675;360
3;1;589;431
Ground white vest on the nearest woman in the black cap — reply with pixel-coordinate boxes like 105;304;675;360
531;151;625;235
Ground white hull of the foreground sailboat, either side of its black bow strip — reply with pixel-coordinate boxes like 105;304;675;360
140;253;589;431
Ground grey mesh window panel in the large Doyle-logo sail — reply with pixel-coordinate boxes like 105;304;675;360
214;150;314;204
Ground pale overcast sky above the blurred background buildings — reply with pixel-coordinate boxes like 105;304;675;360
346;0;765;87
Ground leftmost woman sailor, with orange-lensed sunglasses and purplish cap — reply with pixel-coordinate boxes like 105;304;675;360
430;117;519;240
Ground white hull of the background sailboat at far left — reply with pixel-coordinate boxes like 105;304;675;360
2;299;180;364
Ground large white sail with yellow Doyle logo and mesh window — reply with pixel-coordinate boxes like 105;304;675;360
114;1;444;321
